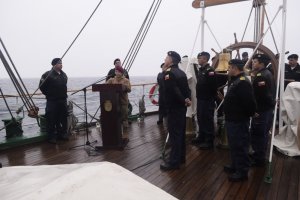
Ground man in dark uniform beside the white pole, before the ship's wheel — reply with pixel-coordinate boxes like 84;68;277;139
251;54;275;166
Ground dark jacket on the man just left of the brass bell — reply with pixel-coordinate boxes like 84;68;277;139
196;64;217;100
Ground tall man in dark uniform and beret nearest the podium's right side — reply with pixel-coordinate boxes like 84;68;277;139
160;51;191;171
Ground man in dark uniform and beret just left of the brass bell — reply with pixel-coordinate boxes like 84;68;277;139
192;52;217;149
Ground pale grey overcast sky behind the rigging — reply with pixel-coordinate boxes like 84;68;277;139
0;0;300;78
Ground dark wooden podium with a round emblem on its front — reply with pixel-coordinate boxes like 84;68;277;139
92;84;125;150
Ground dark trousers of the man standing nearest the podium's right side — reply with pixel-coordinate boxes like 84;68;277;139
168;107;186;166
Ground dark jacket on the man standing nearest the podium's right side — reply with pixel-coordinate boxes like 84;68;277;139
164;65;191;109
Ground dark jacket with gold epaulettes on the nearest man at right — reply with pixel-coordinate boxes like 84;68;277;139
224;73;256;122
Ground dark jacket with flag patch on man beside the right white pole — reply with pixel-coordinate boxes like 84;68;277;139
252;68;276;112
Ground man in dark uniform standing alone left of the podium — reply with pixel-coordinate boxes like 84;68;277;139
39;58;68;144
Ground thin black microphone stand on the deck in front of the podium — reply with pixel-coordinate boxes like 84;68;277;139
69;77;106;153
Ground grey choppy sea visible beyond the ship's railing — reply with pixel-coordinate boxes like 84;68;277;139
0;76;158;140
